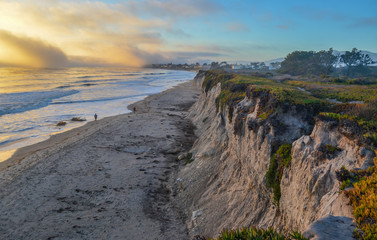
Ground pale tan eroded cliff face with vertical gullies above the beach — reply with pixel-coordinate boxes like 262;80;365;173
178;73;374;239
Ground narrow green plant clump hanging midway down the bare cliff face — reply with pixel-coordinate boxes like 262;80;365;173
266;144;292;206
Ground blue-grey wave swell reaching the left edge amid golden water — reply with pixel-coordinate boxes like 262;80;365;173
0;90;79;116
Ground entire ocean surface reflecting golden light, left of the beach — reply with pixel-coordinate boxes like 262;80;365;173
0;68;196;161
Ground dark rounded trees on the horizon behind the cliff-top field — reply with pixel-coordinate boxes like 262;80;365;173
279;48;376;76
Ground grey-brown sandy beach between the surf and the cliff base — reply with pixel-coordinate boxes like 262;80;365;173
0;82;199;239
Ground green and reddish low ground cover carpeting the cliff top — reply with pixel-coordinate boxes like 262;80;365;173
203;71;377;126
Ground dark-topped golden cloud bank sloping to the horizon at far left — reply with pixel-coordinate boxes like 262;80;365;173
0;30;68;67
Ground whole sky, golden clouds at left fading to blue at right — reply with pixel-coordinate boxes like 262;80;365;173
0;0;377;67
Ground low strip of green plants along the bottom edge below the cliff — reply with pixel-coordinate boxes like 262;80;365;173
213;227;306;240
